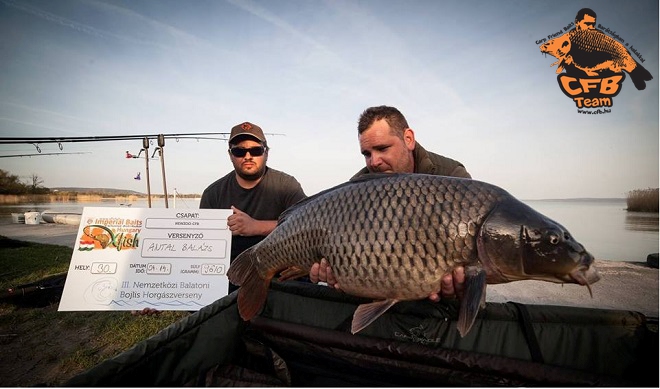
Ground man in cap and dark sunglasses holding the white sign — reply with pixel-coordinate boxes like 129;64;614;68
199;122;306;293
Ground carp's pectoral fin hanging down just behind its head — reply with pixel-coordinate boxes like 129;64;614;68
456;266;486;338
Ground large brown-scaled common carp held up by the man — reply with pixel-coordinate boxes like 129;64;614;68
227;174;599;336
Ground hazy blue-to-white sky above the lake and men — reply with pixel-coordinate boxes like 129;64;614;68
0;0;660;199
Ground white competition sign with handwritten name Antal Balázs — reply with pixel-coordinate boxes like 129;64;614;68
58;207;232;311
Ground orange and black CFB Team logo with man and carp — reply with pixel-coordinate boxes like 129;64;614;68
536;8;653;114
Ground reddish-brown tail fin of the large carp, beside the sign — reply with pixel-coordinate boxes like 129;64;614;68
227;247;274;321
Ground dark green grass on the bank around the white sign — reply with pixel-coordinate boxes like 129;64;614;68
0;236;189;386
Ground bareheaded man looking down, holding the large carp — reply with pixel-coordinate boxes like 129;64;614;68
309;105;472;301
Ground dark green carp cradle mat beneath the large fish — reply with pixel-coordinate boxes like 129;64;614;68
66;281;658;386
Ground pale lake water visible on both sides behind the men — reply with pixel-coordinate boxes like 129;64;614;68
0;198;659;262
